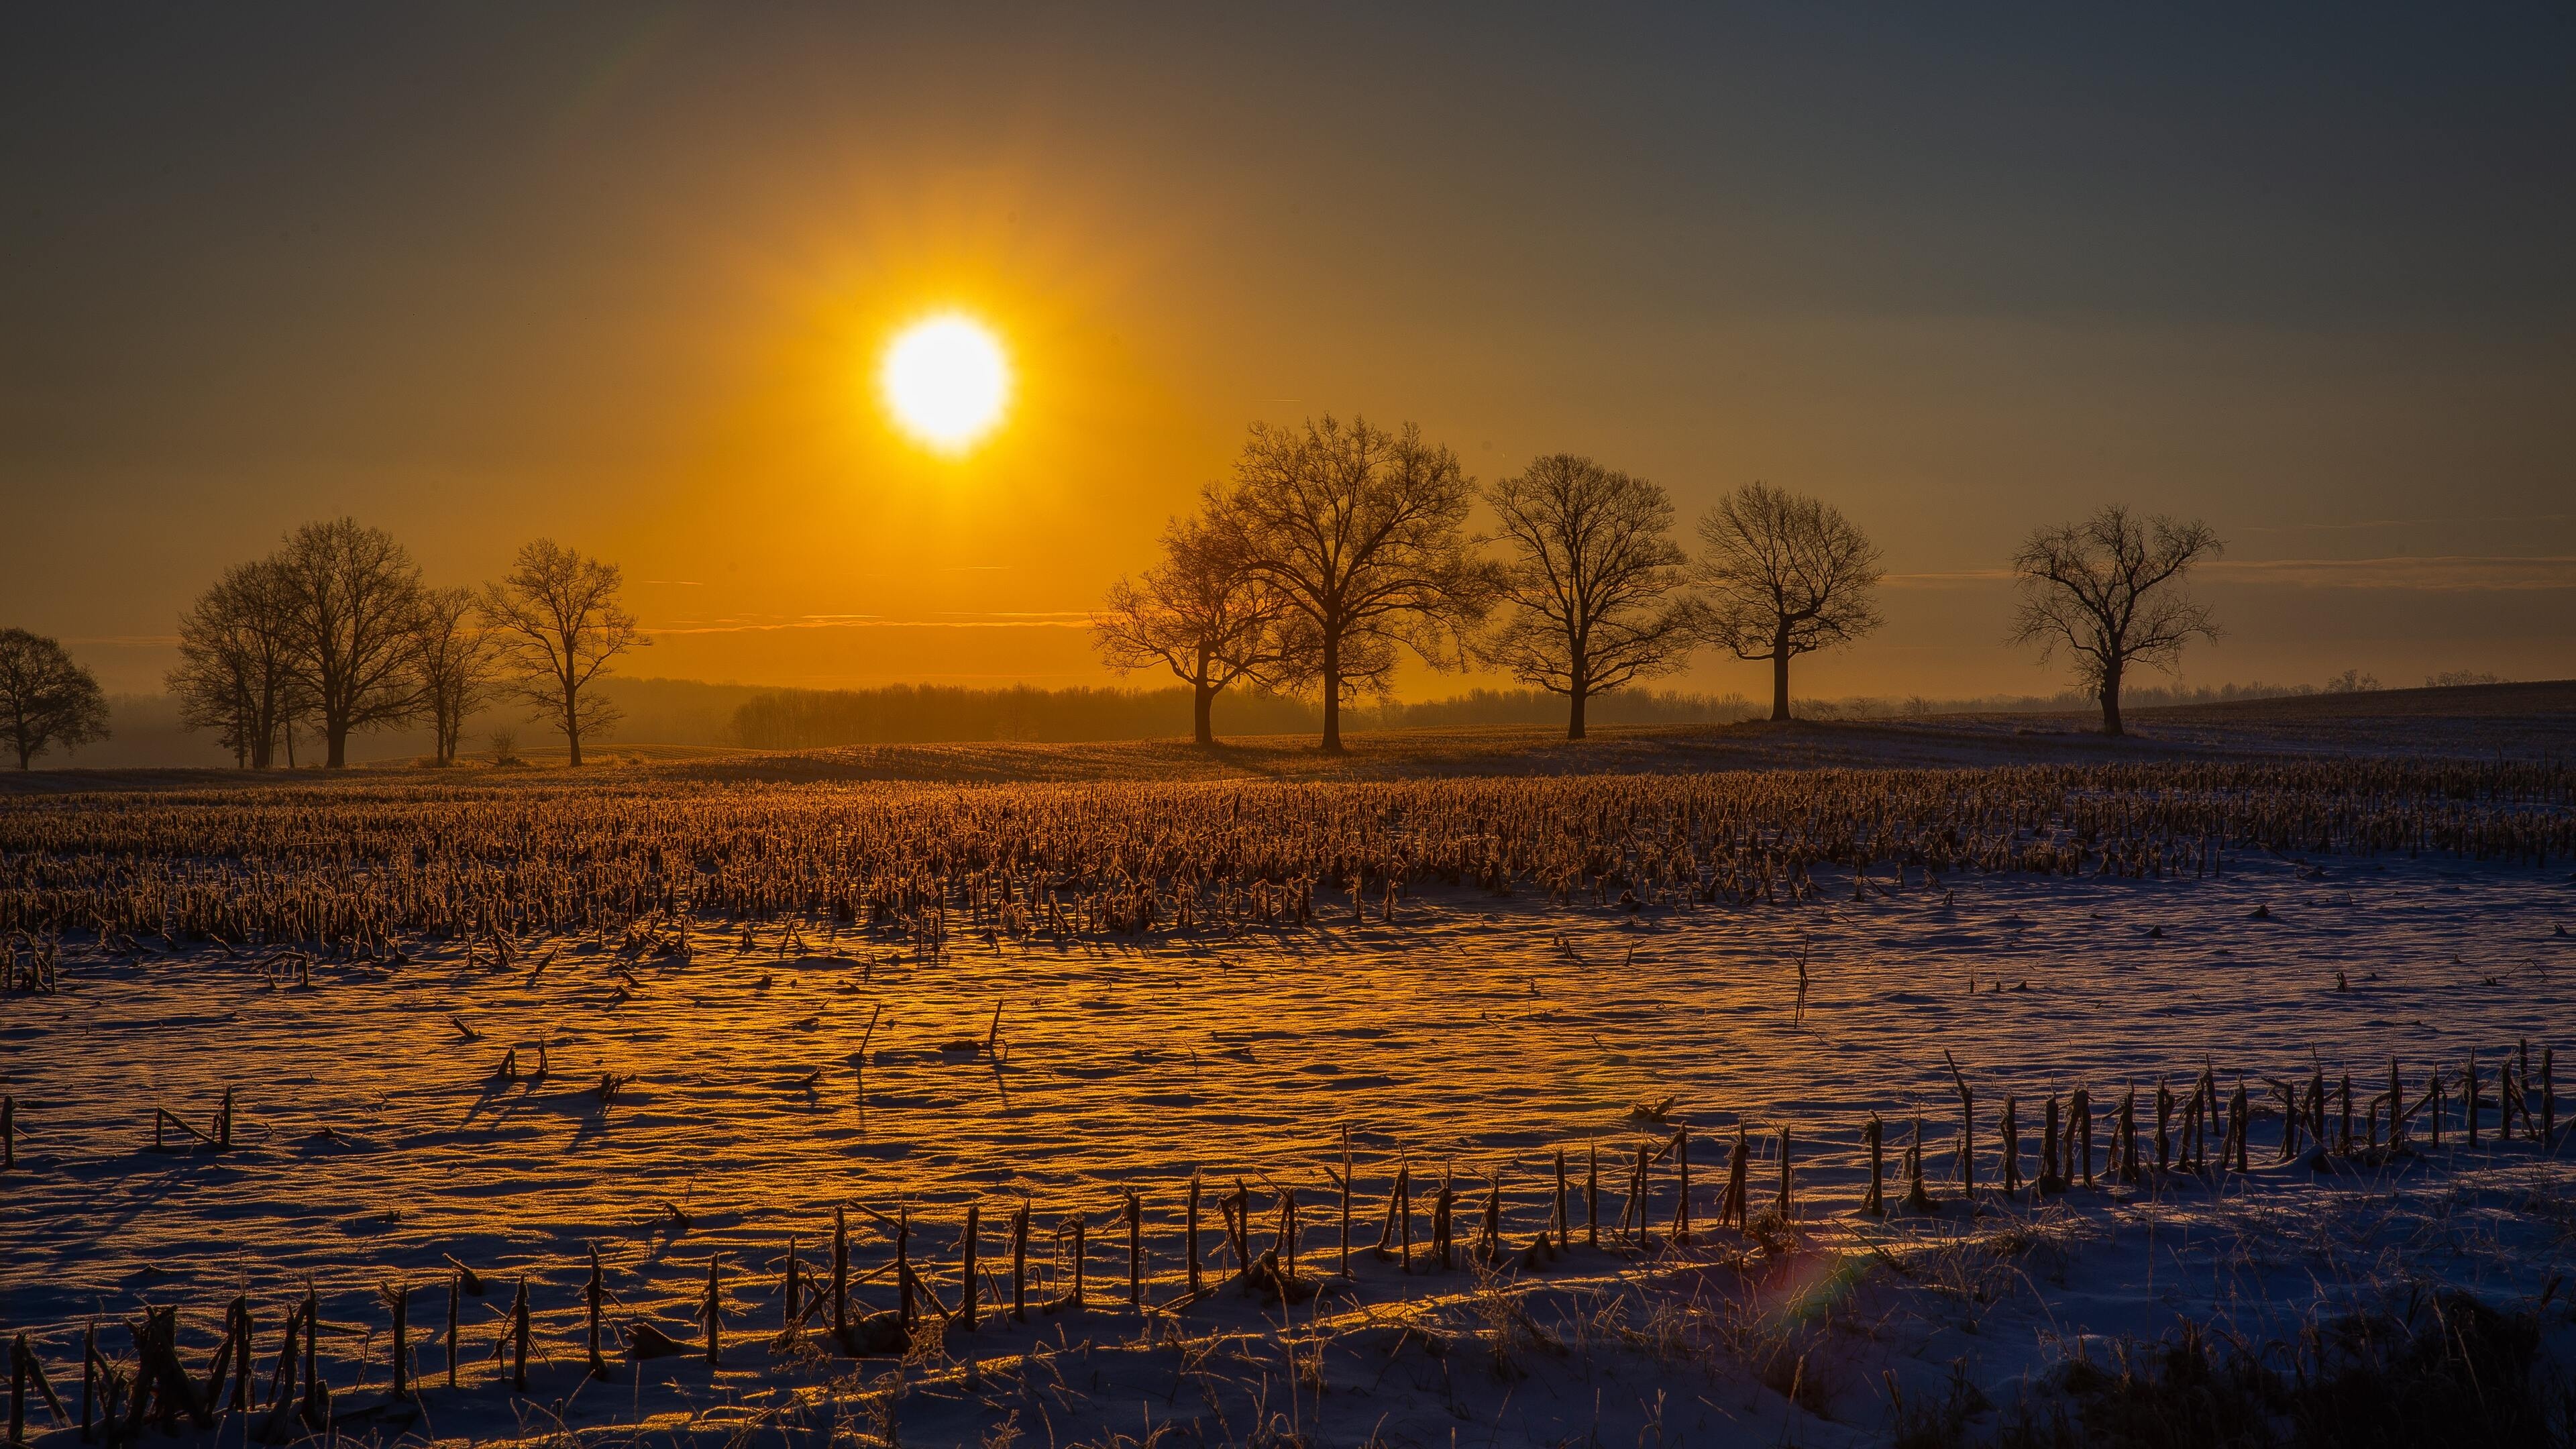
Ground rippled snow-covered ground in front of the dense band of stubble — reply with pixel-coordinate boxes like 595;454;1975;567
0;820;2576;1444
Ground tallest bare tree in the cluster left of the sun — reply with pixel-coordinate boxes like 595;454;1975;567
273;519;420;768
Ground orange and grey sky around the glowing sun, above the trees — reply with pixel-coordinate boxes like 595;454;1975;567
0;5;2576;699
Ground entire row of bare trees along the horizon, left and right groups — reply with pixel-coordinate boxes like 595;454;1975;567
0;415;2223;768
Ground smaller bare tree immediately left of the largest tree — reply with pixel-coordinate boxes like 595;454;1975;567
1092;513;1288;745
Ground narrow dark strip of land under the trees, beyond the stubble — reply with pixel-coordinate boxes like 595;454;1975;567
0;681;2576;797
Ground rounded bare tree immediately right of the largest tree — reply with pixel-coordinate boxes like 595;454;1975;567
1484;453;1693;740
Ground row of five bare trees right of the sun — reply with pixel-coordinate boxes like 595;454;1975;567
1095;415;2220;750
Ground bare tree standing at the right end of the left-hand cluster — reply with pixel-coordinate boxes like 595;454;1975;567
482;539;652;768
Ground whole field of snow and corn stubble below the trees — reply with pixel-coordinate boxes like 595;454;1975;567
0;709;2576;1444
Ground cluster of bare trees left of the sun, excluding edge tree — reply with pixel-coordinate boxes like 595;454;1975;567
168;519;652;771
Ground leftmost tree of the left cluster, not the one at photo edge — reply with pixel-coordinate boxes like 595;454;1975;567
168;559;312;771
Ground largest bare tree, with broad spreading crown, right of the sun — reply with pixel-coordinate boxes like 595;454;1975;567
1208;418;1502;753
